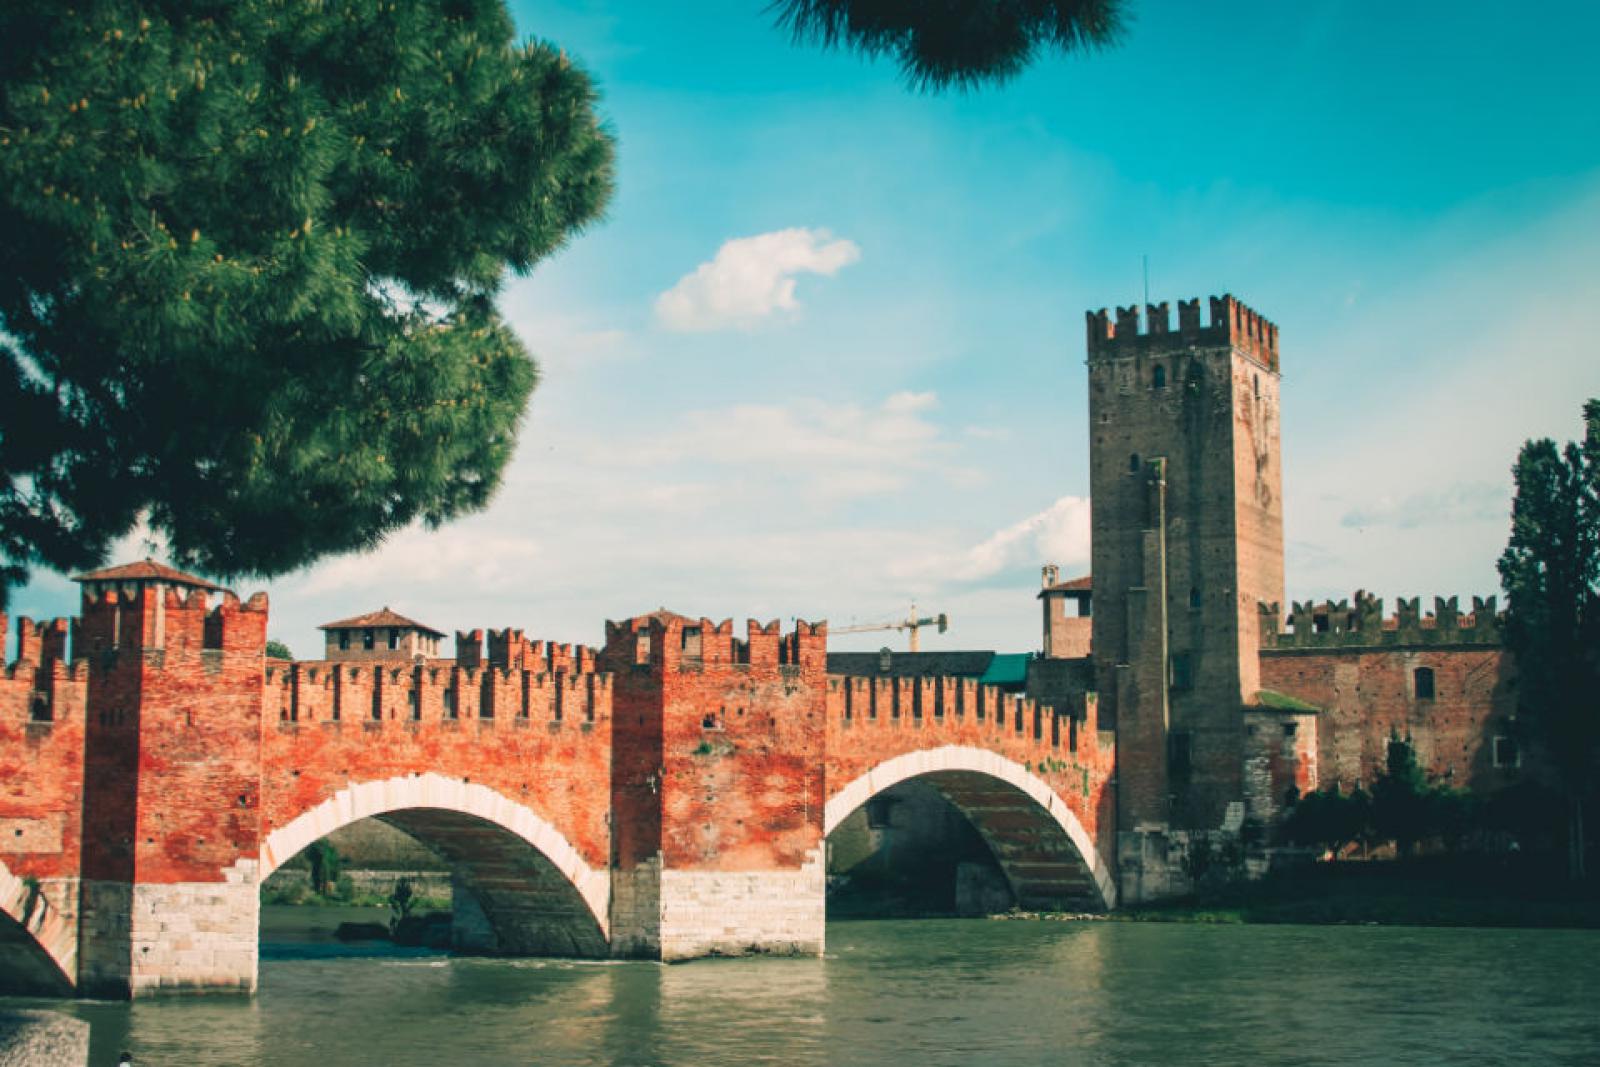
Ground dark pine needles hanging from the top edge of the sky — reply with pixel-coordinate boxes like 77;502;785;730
770;0;1123;90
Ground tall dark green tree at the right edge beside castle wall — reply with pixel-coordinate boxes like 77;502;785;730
1499;400;1600;878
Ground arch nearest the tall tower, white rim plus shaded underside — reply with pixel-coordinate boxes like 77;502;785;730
822;745;1117;909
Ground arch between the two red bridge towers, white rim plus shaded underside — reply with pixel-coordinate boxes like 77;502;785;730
261;771;611;957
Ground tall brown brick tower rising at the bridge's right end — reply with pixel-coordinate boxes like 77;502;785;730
1088;296;1283;901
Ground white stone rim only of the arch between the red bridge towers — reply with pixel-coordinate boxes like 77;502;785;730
261;771;611;936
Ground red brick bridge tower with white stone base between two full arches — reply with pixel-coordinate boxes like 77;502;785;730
598;611;827;960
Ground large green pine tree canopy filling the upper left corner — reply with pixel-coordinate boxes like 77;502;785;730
0;0;613;595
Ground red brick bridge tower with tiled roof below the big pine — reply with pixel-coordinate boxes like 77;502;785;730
74;561;267;997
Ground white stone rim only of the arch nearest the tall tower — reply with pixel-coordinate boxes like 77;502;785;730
822;745;1117;909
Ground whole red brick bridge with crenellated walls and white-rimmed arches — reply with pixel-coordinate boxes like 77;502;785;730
0;565;1115;997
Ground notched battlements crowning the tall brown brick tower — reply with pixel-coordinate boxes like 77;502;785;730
1085;294;1278;370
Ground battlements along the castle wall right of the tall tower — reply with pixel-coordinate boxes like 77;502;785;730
1261;589;1501;649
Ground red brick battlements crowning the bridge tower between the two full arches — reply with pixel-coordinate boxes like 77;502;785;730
600;609;827;672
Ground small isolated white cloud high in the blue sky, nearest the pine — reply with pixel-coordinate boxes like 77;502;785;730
656;227;861;333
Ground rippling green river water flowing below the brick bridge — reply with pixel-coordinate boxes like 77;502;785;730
18;909;1600;1067
